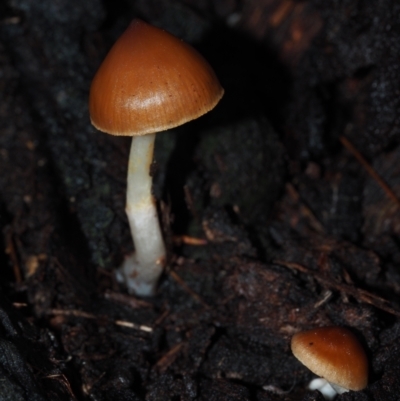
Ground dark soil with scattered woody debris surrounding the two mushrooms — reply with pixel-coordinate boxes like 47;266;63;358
0;0;400;401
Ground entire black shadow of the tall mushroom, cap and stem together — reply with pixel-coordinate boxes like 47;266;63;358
163;21;291;234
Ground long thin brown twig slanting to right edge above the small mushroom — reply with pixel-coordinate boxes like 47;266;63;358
273;260;400;317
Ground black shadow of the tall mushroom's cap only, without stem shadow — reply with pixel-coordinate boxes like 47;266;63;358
196;25;292;127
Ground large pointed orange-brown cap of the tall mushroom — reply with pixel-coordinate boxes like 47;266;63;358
89;19;224;136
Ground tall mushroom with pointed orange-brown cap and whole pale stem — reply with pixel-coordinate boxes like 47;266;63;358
89;19;224;296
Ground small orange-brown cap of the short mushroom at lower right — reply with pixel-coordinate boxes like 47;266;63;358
291;327;368;391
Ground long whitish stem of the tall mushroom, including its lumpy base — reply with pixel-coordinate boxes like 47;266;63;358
121;134;165;296
